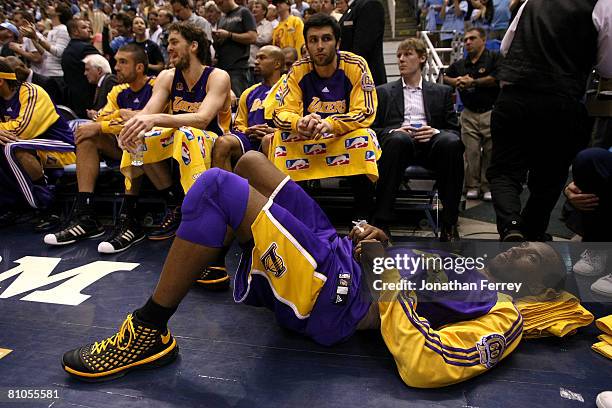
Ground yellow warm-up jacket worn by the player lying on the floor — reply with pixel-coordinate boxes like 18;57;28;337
378;248;523;388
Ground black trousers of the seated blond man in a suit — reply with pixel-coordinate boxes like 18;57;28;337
374;131;465;226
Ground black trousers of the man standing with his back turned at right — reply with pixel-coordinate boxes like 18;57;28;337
487;86;589;240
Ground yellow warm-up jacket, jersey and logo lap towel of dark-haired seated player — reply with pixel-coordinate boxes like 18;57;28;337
268;51;381;181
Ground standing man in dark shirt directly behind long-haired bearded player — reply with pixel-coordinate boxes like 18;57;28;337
214;0;257;96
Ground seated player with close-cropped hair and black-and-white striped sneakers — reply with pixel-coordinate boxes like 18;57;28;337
44;44;174;253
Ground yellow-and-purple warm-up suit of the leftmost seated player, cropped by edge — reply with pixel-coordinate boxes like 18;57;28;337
0;82;76;208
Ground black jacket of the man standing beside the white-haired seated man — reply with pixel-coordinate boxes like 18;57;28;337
62;38;99;118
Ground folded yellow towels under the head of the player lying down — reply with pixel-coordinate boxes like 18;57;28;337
516;290;594;339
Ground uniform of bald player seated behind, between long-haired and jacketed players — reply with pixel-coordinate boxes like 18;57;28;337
234;82;272;151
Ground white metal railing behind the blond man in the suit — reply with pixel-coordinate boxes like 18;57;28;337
419;31;463;83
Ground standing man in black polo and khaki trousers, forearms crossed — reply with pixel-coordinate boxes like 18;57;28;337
444;27;500;201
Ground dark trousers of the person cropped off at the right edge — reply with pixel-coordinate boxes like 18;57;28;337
572;147;612;242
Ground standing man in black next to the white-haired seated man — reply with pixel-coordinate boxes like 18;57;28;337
62;18;98;118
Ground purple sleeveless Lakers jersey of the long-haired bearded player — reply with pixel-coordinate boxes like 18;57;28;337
170;66;232;136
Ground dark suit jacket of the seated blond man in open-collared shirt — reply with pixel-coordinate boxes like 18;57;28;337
372;79;460;139
